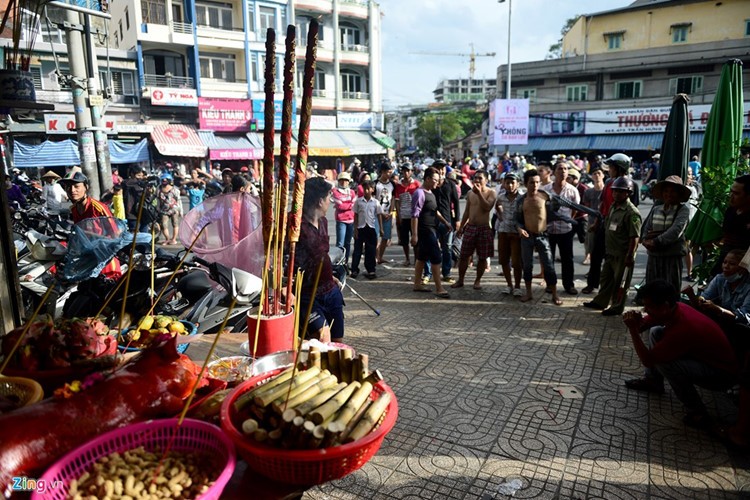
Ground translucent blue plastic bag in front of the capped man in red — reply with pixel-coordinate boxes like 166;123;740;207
63;217;151;281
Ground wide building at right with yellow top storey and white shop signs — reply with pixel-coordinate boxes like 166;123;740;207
495;0;750;157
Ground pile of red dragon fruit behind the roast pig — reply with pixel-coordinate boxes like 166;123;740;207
0;318;117;371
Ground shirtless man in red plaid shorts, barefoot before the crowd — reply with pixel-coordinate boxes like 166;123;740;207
451;170;497;290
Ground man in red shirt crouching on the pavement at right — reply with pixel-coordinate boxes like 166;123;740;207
622;280;739;429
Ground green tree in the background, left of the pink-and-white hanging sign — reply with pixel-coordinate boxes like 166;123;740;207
414;109;483;154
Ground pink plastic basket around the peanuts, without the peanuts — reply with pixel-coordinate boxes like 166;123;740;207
31;418;237;500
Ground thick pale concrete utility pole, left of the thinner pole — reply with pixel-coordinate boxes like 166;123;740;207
63;10;102;199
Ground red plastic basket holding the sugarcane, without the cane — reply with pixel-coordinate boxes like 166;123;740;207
221;370;398;486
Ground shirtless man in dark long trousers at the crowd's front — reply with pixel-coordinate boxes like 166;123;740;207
516;169;562;306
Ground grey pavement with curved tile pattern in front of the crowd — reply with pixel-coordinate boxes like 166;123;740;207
190;242;750;499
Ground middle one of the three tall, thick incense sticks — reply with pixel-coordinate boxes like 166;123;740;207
274;24;297;315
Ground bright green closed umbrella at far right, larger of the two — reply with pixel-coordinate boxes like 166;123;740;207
685;59;743;245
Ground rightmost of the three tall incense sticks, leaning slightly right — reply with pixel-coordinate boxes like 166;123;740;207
286;19;318;312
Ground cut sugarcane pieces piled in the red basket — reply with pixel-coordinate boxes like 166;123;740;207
234;348;391;449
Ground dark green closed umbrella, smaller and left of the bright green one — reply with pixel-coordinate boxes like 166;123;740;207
659;94;690;184
